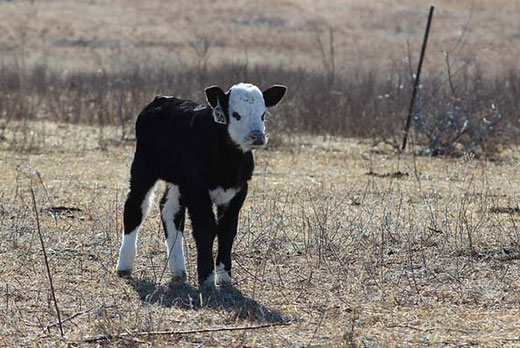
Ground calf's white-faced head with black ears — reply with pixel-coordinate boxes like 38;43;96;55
204;83;287;152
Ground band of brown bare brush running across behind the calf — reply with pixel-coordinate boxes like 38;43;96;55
0;59;520;155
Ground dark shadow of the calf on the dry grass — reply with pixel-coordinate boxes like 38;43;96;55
126;278;293;323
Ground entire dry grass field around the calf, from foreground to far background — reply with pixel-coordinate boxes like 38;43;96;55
0;0;520;348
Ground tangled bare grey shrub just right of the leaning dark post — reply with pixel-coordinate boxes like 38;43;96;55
415;63;517;156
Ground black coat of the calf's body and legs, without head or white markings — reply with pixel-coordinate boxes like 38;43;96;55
124;96;254;282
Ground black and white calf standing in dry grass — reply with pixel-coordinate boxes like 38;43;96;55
117;83;286;285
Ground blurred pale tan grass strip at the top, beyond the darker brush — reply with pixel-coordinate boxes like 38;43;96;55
0;0;520;72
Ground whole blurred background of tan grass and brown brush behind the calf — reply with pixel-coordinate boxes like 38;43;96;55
0;0;520;155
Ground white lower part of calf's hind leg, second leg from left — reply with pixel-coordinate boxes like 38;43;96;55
162;184;186;278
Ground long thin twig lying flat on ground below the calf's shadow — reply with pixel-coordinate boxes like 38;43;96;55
81;323;291;343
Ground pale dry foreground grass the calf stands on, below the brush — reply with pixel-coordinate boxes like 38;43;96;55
0;122;520;347
